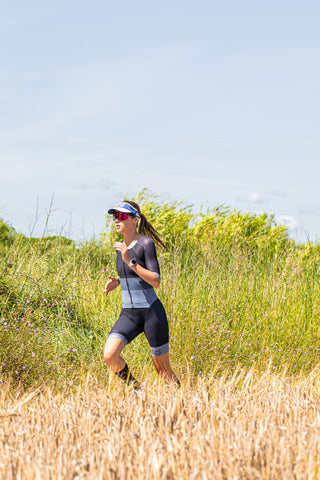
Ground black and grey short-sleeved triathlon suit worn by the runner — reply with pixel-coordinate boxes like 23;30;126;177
109;235;169;357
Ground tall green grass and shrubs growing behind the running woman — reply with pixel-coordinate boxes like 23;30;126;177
0;191;320;387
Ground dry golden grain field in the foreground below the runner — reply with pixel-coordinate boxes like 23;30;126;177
0;372;320;480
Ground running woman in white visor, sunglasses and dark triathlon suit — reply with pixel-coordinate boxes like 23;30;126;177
103;200;180;388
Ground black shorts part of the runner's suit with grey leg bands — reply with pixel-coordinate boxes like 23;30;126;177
108;299;169;357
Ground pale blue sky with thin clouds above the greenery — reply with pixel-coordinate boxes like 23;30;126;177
0;0;320;241
